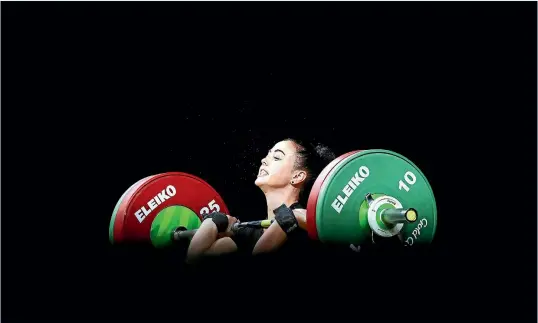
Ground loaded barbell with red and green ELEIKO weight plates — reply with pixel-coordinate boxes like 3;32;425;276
109;149;437;247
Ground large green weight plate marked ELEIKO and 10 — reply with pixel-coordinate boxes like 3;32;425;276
316;149;437;246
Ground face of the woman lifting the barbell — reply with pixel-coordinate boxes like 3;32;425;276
254;141;297;191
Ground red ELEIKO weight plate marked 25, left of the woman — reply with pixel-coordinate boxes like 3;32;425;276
115;172;229;241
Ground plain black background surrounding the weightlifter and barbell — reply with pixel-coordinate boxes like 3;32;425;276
2;2;536;321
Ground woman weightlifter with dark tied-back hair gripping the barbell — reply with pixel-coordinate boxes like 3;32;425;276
186;139;336;263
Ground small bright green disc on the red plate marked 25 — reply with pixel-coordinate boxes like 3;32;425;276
150;205;201;248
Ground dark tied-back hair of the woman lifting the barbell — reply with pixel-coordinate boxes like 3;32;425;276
286;138;336;207
